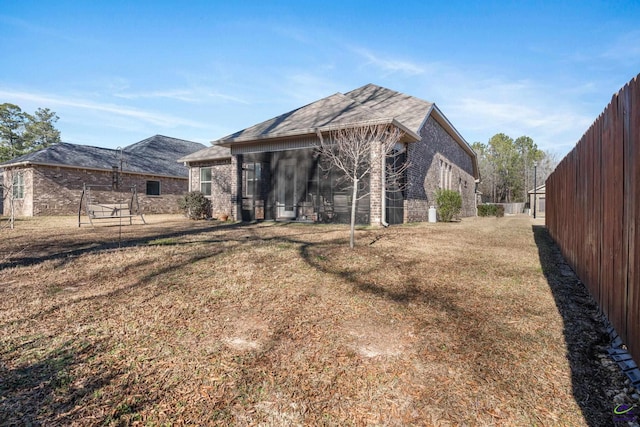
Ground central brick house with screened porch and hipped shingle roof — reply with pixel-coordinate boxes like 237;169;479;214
180;84;479;225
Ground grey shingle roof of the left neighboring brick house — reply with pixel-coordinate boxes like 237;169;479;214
0;135;205;177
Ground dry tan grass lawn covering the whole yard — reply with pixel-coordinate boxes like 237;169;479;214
0;216;624;426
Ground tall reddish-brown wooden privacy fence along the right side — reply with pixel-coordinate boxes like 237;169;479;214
546;75;640;361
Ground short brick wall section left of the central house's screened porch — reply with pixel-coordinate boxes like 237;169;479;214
189;159;233;217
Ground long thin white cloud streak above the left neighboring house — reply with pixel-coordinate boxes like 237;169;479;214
0;89;206;128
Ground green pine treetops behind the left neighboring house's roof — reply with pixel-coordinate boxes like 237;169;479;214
0;103;60;162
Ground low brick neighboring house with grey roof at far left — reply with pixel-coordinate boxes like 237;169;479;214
0;135;205;216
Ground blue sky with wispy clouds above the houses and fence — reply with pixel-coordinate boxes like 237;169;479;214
0;0;640;157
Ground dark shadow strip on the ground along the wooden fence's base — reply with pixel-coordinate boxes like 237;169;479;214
532;225;624;427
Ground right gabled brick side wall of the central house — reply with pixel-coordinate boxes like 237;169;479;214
405;117;476;222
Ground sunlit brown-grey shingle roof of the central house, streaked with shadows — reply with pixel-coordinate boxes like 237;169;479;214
216;84;433;145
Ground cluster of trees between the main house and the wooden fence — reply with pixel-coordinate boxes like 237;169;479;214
472;133;558;203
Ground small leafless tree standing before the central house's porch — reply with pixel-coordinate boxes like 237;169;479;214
317;123;407;248
